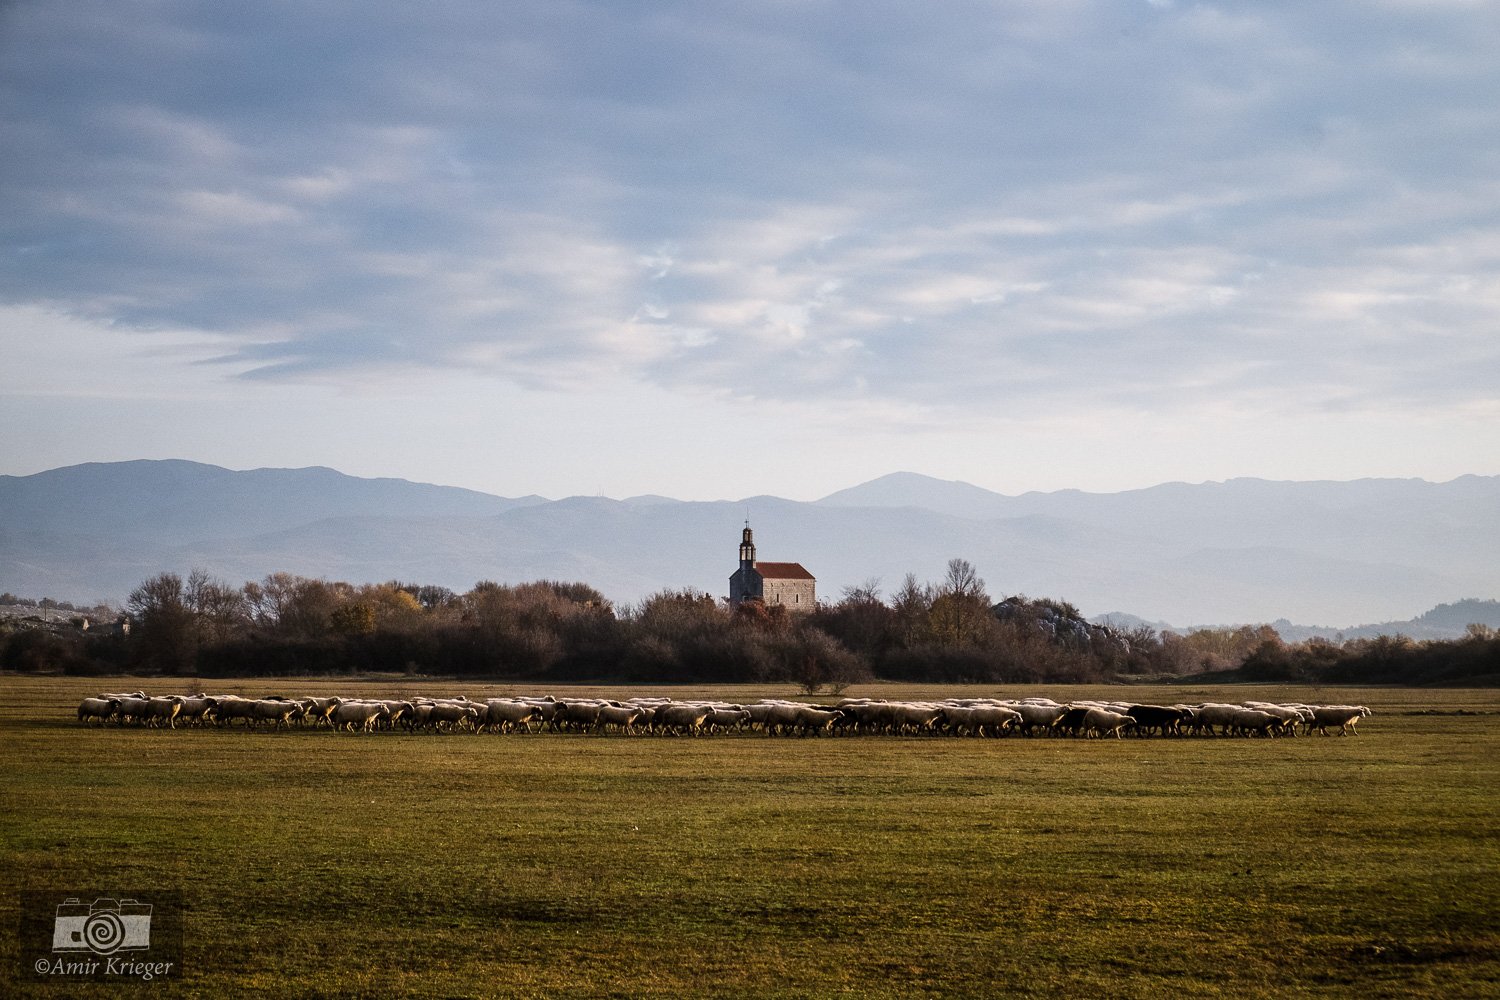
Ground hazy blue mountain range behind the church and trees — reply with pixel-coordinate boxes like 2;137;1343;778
0;462;1500;628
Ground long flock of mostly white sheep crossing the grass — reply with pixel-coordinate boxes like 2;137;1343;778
78;691;1370;739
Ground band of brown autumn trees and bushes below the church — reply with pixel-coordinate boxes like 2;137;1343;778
0;559;1500;691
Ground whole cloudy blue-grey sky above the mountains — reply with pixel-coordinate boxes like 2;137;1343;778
0;0;1500;499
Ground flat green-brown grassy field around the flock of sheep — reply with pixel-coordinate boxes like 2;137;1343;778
0;676;1500;999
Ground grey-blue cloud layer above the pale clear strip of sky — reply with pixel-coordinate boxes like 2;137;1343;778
0;0;1500;434
